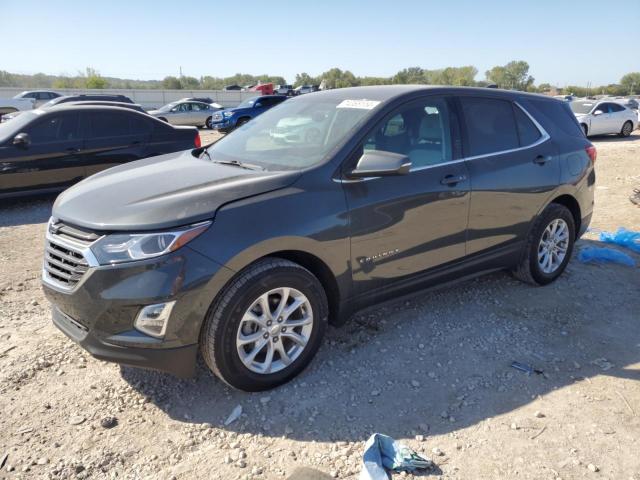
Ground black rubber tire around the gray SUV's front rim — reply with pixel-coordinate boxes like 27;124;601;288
200;257;329;392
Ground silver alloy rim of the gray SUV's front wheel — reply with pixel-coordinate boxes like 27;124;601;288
236;287;313;374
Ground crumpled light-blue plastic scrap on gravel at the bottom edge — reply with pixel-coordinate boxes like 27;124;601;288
359;433;433;480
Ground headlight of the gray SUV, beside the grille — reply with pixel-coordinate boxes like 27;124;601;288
91;222;211;265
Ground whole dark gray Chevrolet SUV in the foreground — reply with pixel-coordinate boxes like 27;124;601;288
43;86;596;391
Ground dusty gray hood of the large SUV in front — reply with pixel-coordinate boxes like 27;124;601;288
52;151;300;231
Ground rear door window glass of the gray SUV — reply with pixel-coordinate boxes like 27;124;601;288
460;97;520;157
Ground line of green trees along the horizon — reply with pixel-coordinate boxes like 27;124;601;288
0;60;640;97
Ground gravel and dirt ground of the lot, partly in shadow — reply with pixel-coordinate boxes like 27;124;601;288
0;131;640;480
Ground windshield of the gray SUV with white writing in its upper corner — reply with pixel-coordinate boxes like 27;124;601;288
209;96;380;170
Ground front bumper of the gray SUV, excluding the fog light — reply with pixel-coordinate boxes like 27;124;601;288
43;246;232;376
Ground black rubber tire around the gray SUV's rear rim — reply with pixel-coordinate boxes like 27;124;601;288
512;203;576;285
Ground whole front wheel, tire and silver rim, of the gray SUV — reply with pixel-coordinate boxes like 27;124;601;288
200;258;328;392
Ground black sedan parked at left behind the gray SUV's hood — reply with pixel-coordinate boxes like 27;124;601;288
0;105;200;197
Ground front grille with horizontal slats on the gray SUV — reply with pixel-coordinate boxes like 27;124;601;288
43;222;99;290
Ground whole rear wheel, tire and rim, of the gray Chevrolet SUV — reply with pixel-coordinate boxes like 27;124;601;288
513;203;576;285
